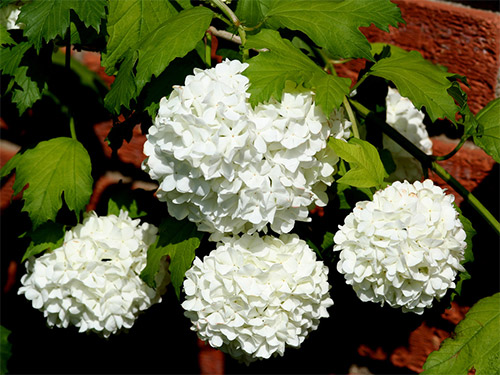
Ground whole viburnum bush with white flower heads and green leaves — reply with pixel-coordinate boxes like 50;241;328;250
0;0;500;374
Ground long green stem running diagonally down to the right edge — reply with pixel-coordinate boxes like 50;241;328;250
349;99;500;235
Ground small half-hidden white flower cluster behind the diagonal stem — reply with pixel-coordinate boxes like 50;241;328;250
383;87;432;182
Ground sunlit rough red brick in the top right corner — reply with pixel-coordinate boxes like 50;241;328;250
338;0;500;113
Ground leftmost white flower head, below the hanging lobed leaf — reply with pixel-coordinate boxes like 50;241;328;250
18;212;169;337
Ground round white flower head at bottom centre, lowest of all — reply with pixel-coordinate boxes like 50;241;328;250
182;233;333;364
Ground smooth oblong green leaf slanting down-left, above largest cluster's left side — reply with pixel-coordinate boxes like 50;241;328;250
136;7;214;91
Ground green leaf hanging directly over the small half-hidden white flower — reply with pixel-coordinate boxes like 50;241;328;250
368;51;458;121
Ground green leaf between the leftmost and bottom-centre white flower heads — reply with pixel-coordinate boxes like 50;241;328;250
141;218;203;298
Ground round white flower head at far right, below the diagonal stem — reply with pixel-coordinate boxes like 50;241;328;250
334;180;466;314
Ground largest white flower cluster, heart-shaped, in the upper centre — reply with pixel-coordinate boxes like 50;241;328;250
143;60;350;239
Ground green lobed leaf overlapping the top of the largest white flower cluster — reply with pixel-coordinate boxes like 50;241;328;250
243;30;351;114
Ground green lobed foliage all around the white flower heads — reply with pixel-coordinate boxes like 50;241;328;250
0;0;500;373
